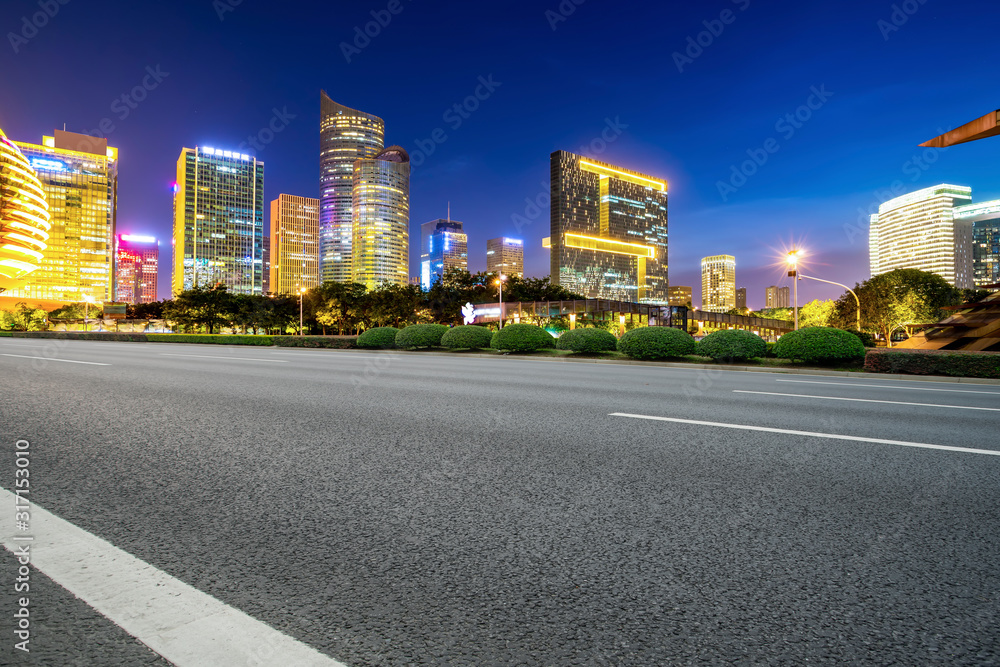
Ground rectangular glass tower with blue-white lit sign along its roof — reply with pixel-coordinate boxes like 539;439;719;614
172;147;264;296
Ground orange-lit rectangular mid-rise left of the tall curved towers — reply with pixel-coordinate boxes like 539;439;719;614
268;195;320;294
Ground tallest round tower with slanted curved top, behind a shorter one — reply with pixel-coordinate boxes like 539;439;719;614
319;91;385;282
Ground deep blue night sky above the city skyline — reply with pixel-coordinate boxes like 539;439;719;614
0;0;1000;308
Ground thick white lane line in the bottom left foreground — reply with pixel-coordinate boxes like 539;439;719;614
0;487;345;667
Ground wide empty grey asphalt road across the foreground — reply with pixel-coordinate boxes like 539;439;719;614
0;339;1000;667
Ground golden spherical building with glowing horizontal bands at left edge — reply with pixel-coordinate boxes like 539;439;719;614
0;130;52;293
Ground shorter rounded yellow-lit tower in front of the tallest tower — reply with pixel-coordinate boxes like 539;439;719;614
351;146;410;289
